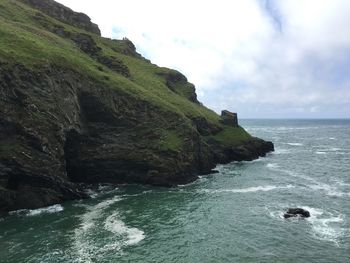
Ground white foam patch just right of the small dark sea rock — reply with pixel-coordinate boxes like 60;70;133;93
302;206;345;246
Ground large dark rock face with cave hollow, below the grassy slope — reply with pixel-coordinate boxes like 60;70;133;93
0;64;215;210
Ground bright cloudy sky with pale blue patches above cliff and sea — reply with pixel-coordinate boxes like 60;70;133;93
58;0;350;118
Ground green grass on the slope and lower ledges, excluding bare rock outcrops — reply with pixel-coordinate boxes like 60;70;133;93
0;0;249;150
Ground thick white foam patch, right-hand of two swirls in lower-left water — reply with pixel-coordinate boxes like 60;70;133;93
104;213;145;248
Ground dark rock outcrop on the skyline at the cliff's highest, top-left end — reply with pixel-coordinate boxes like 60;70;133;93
21;0;101;36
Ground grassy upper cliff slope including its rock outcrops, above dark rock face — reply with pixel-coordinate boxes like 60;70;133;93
0;0;250;144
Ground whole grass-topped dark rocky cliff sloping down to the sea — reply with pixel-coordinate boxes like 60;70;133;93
0;0;273;212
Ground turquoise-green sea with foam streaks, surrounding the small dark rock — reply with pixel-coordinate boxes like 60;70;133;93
0;120;350;263
